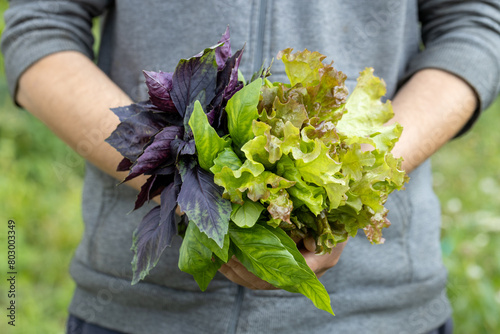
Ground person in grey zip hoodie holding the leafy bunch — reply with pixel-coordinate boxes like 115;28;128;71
2;0;500;334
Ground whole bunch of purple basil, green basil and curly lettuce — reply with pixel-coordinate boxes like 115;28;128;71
107;30;407;314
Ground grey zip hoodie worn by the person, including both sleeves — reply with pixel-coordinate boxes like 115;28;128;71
2;0;500;334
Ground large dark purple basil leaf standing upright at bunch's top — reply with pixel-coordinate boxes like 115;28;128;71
170;49;217;118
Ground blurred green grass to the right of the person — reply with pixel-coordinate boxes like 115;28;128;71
433;99;500;334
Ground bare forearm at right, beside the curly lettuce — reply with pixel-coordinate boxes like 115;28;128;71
392;69;477;173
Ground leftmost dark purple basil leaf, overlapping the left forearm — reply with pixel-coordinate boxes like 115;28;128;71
106;111;168;162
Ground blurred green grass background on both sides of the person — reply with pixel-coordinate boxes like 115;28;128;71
0;2;500;334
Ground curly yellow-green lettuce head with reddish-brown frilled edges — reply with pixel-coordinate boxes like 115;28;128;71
212;49;407;253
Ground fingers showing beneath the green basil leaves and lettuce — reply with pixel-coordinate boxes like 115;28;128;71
219;238;347;290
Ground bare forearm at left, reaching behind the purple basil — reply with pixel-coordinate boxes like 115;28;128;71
16;51;144;193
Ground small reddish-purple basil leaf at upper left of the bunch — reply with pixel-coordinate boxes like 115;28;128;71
143;71;177;113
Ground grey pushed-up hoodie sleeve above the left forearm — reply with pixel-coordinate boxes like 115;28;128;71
1;0;110;97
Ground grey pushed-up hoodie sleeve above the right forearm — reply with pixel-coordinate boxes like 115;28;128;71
406;0;500;132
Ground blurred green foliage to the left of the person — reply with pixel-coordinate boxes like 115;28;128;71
0;1;83;334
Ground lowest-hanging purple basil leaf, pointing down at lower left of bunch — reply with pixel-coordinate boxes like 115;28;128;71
131;204;177;284
